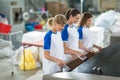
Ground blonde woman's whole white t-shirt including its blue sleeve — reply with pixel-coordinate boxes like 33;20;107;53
43;31;65;74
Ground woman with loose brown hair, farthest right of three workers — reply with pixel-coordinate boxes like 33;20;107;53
78;12;102;52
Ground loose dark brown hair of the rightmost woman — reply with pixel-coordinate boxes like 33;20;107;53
79;12;92;26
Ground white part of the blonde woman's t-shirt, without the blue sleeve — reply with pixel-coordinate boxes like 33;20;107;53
43;32;65;74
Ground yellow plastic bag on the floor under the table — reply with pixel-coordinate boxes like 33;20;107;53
19;49;36;70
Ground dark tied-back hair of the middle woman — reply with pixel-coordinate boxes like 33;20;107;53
65;8;80;20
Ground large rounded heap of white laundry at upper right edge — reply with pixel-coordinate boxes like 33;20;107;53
94;10;120;33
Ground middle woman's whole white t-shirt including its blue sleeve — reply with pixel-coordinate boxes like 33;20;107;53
62;24;79;60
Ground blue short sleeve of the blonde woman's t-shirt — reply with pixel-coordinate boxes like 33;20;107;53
43;33;51;51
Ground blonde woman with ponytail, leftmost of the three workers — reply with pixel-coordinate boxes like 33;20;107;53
43;14;67;74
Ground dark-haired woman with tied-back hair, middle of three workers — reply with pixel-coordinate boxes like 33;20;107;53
62;8;83;61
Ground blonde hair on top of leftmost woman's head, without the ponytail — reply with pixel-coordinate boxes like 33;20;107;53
53;14;67;25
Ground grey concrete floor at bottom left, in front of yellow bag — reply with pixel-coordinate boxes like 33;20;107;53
0;58;41;80
